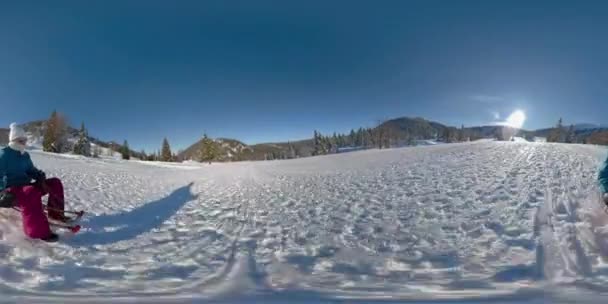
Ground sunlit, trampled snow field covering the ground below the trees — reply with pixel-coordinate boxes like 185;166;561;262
0;142;608;303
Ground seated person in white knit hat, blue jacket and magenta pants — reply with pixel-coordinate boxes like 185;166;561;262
0;123;67;242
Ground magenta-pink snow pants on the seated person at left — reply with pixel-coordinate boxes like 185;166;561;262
8;178;64;239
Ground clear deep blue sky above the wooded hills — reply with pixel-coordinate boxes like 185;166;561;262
0;0;608;151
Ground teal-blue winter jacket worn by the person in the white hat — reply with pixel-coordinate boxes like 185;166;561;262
0;147;44;191
